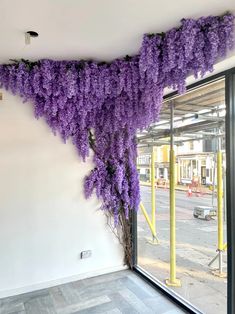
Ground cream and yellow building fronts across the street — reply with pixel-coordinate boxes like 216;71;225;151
137;140;222;186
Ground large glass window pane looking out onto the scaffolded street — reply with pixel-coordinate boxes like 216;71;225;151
138;79;227;314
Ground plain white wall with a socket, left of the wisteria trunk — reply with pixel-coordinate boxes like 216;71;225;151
0;90;123;298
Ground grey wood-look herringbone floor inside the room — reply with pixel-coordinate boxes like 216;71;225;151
0;270;185;314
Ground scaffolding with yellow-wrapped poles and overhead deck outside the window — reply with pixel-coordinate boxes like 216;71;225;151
138;79;227;287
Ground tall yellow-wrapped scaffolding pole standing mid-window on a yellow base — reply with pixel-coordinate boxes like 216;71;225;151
166;104;181;287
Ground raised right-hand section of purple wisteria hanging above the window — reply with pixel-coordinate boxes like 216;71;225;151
139;13;234;95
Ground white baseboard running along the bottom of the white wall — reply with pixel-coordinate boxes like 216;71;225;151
0;265;128;299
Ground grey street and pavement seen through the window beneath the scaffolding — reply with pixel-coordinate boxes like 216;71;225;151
138;186;227;314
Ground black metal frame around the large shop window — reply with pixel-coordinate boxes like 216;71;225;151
132;67;235;314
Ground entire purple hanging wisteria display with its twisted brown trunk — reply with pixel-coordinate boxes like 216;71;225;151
0;13;234;265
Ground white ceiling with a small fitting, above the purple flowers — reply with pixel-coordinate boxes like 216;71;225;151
0;0;235;63
